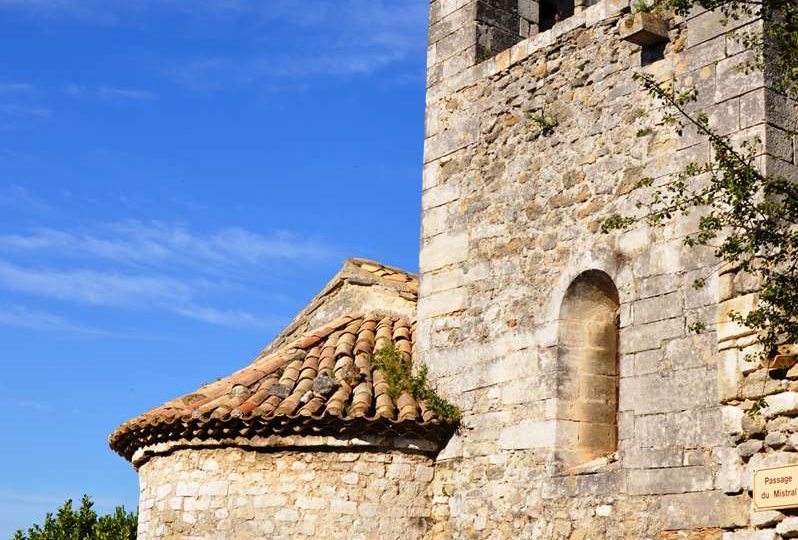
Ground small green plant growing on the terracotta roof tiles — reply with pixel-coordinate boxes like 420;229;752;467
372;345;461;422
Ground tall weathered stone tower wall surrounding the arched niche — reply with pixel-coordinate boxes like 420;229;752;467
417;0;795;540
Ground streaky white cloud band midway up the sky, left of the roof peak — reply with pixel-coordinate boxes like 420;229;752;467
0;221;337;332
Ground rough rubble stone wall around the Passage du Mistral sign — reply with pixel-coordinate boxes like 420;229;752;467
718;268;798;540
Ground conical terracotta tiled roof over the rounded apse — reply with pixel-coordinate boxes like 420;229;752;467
109;314;454;460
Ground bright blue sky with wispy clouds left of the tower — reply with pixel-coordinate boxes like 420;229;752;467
0;0;427;538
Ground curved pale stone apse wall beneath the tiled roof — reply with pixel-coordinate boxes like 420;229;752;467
138;448;433;540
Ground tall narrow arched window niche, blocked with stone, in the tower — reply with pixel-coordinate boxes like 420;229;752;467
556;270;620;469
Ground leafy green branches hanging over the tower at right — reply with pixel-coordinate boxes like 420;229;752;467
602;0;798;358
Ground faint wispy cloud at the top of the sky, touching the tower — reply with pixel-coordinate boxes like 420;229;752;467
173;0;426;85
